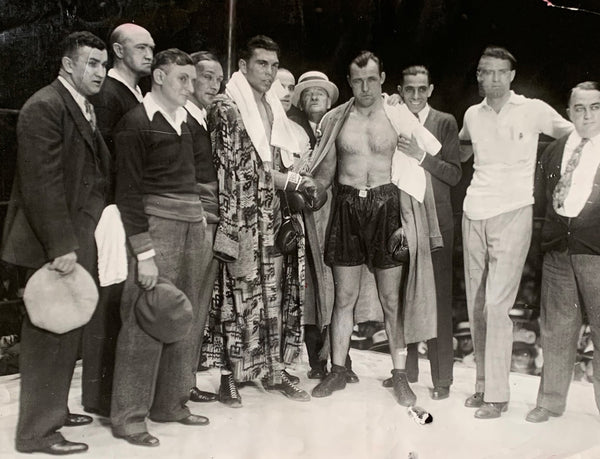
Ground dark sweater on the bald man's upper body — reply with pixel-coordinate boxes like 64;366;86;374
89;73;139;158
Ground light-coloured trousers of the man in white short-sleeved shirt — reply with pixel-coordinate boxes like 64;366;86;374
462;206;533;402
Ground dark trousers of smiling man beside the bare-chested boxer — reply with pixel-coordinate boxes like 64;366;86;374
406;227;454;387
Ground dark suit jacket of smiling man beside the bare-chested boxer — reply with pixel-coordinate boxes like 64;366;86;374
421;108;462;233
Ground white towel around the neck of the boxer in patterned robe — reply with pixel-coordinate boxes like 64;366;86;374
225;71;300;167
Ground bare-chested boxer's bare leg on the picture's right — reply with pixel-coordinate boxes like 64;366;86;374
375;266;406;370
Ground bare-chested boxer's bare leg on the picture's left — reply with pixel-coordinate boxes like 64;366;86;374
331;265;362;367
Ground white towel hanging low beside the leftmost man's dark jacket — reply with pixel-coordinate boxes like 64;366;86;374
94;204;127;287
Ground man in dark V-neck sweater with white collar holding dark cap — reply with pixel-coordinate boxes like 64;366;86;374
111;49;208;446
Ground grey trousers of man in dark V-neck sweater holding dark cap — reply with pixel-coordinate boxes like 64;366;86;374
111;216;204;436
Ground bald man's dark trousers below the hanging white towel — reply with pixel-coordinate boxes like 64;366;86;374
81;282;125;413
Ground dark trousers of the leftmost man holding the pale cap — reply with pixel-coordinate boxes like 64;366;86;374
16;212;97;451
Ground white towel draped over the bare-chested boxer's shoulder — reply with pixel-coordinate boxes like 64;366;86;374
383;96;442;202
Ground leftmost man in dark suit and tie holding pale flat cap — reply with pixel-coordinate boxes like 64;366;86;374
1;32;110;454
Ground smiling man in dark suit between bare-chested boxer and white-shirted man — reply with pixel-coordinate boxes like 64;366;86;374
384;65;461;400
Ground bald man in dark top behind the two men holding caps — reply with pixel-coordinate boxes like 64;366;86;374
88;24;154;417
